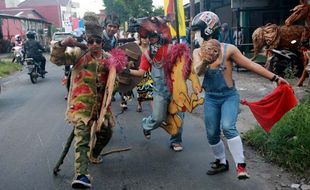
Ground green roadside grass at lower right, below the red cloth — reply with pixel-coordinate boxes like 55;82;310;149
244;97;310;179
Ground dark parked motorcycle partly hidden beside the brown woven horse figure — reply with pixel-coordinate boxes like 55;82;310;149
267;49;303;78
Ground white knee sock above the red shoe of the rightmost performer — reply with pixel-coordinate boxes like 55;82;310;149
227;136;244;165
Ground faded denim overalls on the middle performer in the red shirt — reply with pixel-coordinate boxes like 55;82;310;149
142;46;184;143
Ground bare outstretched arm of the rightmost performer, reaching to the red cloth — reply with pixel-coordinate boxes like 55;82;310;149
229;45;289;84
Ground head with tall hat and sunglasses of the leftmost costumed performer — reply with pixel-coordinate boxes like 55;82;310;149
83;12;103;54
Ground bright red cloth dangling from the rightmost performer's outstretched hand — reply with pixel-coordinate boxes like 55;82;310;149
240;84;297;133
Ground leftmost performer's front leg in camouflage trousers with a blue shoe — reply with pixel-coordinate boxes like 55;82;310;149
72;122;91;188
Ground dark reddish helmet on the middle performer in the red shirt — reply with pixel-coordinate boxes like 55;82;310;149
138;17;172;44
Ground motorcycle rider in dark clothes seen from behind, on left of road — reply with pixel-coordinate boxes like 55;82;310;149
24;31;47;75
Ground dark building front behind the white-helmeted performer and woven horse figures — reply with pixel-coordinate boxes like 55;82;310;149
184;0;299;46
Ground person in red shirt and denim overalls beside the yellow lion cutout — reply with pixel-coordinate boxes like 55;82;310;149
128;17;184;152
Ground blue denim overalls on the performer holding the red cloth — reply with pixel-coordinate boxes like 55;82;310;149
202;44;240;145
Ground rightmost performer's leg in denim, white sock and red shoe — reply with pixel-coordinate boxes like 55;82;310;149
222;93;250;179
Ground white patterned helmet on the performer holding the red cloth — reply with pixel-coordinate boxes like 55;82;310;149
192;11;221;40
